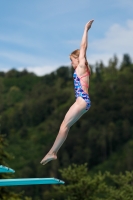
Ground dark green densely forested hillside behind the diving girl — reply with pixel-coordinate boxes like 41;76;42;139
0;54;133;200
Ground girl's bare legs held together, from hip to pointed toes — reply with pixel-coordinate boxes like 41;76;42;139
41;97;87;165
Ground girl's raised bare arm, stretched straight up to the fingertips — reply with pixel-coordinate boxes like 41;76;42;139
79;20;94;67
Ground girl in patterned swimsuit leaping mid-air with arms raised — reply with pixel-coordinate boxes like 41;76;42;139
41;20;94;165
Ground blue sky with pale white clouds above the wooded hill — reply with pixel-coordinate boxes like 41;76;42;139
0;0;133;76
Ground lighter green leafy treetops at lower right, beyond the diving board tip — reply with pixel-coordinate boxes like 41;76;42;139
54;164;133;200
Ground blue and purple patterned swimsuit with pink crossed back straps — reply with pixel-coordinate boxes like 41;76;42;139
73;70;91;110
